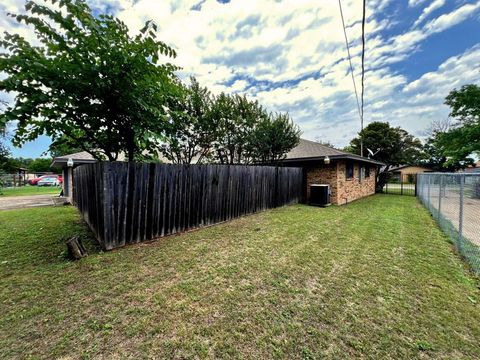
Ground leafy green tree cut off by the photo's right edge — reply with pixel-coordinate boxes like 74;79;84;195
435;84;480;166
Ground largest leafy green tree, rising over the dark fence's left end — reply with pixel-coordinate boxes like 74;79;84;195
0;0;179;160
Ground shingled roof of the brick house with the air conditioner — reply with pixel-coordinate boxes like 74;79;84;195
283;139;384;165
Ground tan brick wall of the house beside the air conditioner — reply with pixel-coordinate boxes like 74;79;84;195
307;161;376;205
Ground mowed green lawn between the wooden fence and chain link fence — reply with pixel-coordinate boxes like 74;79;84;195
0;195;480;359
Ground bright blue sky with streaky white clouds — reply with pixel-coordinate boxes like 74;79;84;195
0;0;480;157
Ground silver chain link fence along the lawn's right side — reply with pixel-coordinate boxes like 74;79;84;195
417;173;480;274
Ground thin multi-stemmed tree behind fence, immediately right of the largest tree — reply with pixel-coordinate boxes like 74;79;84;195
160;77;217;164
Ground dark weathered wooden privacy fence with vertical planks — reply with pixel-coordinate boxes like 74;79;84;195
73;162;303;250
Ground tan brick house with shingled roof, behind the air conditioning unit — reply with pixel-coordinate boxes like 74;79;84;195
282;139;384;205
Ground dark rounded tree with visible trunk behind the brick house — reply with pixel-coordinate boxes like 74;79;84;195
350;121;422;191
